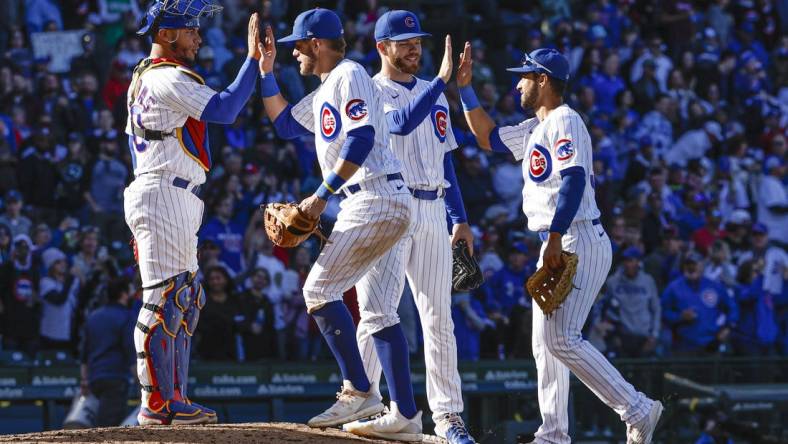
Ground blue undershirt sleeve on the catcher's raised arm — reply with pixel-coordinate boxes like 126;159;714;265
200;57;257;124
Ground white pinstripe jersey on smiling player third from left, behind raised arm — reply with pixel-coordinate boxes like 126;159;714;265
372;73;457;190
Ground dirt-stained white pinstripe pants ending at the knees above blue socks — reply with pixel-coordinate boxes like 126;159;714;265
304;176;411;320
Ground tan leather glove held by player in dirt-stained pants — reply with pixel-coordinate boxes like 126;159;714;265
261;203;325;248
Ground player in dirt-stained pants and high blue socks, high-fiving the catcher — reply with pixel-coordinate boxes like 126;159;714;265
260;9;421;441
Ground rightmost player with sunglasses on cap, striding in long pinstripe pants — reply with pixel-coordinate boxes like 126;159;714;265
457;43;662;444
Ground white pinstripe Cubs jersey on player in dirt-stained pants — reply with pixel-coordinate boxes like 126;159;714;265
290;59;401;187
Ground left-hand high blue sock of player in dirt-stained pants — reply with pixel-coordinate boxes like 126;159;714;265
312;301;369;392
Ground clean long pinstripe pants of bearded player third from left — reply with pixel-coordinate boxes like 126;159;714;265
356;198;463;419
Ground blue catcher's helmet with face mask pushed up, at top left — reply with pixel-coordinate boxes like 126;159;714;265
137;0;224;35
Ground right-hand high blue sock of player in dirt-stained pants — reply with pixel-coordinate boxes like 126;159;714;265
372;324;416;419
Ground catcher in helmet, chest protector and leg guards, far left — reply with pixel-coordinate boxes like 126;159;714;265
123;0;259;425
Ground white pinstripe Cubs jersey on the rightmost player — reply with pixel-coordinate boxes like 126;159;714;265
498;105;599;231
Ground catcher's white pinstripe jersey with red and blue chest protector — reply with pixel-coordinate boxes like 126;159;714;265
126;66;216;184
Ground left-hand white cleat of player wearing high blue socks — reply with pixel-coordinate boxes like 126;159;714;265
306;381;385;428
